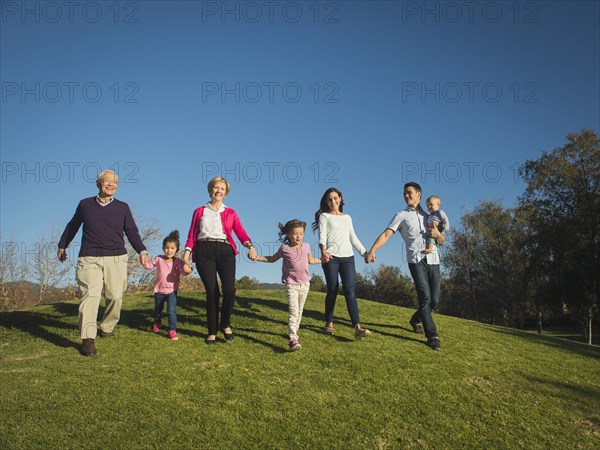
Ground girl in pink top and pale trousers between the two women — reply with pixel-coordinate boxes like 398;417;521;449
255;220;321;352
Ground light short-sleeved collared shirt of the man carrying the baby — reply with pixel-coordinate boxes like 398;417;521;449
387;206;440;265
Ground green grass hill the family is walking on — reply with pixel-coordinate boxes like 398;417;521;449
0;291;600;449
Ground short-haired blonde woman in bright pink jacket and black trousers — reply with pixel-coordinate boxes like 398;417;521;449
183;177;256;344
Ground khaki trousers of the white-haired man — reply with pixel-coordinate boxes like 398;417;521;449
77;255;127;339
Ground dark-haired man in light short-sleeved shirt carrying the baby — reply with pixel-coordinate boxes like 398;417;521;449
365;182;445;350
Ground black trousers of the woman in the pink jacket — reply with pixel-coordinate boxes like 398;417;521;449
194;241;235;334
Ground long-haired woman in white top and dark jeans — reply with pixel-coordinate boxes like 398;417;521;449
312;188;371;339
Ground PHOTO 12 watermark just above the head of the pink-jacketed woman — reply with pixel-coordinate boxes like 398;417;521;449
202;161;340;183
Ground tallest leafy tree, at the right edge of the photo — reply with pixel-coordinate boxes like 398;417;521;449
520;129;600;344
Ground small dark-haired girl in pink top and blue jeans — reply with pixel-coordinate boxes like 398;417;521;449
144;230;192;340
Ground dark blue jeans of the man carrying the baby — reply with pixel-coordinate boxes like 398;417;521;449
408;258;442;338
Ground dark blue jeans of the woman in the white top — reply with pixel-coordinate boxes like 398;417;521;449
321;256;360;326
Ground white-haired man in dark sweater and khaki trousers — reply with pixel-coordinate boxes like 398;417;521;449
58;170;148;356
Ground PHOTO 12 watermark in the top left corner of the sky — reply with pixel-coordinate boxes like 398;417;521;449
0;1;140;24
